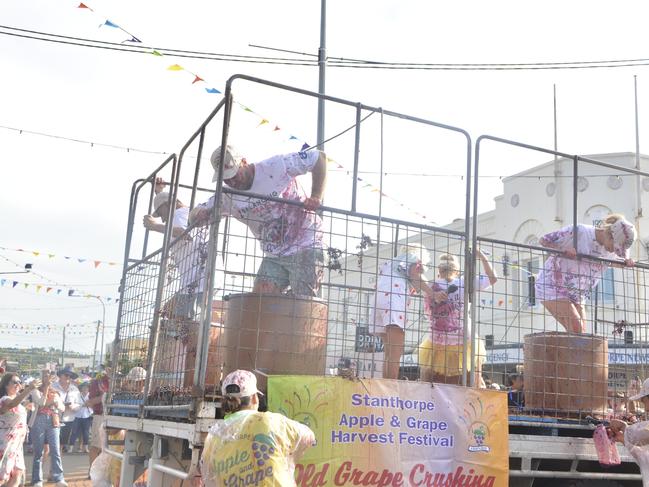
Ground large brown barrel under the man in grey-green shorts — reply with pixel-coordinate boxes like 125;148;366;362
223;293;327;390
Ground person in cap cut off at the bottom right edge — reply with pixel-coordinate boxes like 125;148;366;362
606;379;649;487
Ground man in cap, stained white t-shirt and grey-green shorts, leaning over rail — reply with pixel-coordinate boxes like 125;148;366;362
190;145;327;296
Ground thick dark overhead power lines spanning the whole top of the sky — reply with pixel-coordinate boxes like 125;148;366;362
0;25;649;71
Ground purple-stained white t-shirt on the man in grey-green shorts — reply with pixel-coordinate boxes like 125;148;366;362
200;151;322;256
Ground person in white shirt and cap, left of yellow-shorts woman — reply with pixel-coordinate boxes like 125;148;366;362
374;243;433;379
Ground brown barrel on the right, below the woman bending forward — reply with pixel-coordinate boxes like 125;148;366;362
524;332;608;415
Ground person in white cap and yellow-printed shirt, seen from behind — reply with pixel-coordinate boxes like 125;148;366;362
200;370;315;487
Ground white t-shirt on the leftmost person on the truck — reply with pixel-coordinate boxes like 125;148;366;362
169;206;207;293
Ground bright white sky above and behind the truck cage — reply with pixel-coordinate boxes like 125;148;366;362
0;0;649;351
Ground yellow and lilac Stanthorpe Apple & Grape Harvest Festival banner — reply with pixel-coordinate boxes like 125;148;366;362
268;376;509;487
